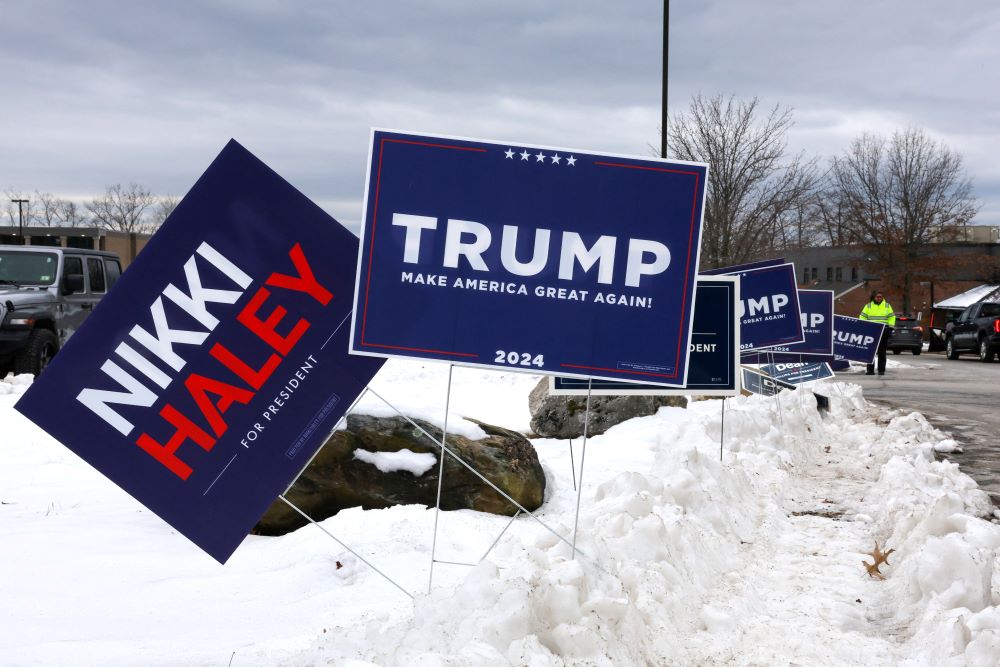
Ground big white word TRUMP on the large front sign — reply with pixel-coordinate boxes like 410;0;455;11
392;213;672;288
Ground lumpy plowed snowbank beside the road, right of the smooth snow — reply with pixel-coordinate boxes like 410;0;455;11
292;378;1000;665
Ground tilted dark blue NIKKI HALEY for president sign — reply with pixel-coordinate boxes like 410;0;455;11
17;141;382;562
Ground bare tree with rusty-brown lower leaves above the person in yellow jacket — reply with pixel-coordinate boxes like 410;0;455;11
826;128;979;311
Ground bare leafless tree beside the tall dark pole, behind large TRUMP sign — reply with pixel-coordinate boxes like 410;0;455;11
669;95;817;268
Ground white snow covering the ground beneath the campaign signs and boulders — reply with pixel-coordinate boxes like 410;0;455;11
0;362;1000;666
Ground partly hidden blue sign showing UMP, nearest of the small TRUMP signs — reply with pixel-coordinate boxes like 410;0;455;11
726;264;804;350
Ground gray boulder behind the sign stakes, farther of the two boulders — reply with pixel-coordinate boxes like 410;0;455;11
528;378;687;439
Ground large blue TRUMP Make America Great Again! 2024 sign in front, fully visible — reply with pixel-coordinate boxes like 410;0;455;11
351;130;707;386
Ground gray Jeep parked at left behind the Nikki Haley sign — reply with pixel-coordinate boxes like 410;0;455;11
0;245;121;375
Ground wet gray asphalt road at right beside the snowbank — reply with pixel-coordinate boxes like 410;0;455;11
837;351;1000;506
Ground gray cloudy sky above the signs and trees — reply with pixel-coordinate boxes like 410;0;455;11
0;0;1000;229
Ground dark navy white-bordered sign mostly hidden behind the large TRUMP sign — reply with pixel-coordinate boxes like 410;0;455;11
549;276;740;396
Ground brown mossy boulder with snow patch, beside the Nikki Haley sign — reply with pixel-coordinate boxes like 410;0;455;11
254;415;545;535
